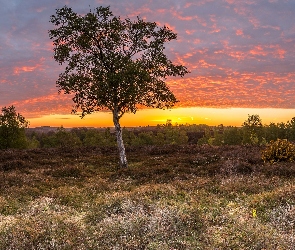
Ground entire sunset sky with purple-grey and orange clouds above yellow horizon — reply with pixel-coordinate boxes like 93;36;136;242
0;0;295;127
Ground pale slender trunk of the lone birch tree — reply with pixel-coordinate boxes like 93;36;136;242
113;110;128;168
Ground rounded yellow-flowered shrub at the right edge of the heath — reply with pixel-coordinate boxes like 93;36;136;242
261;139;295;163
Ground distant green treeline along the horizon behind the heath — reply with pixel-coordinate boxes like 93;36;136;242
18;115;295;148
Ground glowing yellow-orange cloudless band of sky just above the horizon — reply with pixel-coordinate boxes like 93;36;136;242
28;108;295;127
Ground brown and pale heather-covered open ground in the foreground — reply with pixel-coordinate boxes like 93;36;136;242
0;145;295;250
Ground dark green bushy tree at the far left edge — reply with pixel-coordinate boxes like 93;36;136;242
0;106;29;149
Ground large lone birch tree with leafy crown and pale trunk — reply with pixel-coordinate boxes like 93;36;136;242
49;6;188;167
